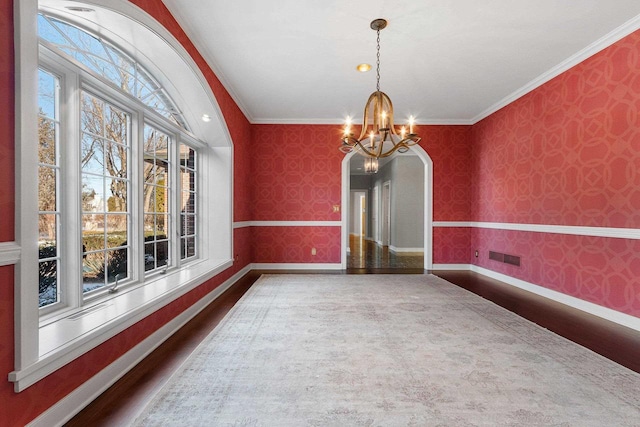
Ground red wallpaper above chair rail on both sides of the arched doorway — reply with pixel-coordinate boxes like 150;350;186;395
251;125;471;221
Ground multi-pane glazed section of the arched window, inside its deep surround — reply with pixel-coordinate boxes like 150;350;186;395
38;13;203;313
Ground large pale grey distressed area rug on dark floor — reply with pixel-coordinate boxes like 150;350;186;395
135;275;640;427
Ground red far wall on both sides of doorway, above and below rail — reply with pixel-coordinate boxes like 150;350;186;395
251;123;471;263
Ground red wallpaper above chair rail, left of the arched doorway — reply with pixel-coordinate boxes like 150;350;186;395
251;125;344;222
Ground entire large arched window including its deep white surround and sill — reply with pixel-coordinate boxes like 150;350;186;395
9;0;233;391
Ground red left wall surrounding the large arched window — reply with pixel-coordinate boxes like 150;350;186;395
0;0;251;426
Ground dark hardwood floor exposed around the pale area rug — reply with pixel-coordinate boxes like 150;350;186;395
66;269;640;427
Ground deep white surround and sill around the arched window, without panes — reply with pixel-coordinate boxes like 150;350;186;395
9;0;233;392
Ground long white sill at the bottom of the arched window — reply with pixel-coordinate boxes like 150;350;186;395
9;259;233;392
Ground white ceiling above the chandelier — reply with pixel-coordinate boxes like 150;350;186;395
163;0;640;124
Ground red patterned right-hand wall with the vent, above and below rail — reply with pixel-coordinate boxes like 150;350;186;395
472;32;640;316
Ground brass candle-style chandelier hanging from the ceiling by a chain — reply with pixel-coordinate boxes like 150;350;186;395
340;19;420;164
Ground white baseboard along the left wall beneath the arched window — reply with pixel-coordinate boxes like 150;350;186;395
28;266;251;427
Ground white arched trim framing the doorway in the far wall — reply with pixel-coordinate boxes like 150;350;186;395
340;145;433;270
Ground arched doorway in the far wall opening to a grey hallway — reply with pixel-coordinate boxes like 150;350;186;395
342;147;433;273
